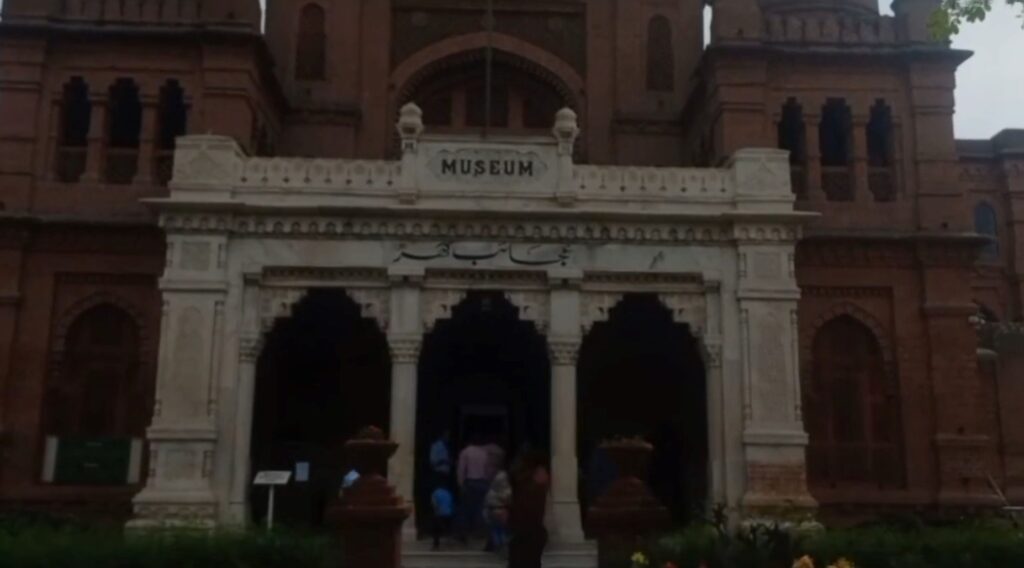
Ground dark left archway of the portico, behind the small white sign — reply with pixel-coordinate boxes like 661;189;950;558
250;290;391;527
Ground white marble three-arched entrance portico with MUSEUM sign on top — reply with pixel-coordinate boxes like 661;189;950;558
134;106;813;540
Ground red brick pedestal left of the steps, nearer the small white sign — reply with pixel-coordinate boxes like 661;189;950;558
333;428;412;568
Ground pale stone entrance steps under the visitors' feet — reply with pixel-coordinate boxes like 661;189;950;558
401;542;597;568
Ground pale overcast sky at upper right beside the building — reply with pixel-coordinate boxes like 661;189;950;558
0;0;1024;138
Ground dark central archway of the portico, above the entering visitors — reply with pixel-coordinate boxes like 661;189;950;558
416;292;551;528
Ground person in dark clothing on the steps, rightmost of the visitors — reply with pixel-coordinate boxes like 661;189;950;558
509;451;551;568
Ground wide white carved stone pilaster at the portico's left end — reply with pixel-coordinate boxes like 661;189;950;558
130;139;235;527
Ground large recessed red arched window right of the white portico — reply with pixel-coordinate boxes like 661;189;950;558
804;315;904;488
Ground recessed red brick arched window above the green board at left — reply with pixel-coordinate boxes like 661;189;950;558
46;304;142;438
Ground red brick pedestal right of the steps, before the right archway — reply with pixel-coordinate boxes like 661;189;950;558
588;440;671;568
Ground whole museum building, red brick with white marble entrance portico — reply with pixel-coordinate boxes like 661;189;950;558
0;0;1024;540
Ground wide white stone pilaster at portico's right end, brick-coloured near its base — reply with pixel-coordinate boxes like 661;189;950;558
732;149;815;514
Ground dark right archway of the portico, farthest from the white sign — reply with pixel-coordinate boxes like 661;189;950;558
577;294;709;523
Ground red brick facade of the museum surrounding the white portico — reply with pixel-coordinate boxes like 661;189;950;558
0;0;1024;517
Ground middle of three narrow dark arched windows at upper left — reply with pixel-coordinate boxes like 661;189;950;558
106;79;142;183
